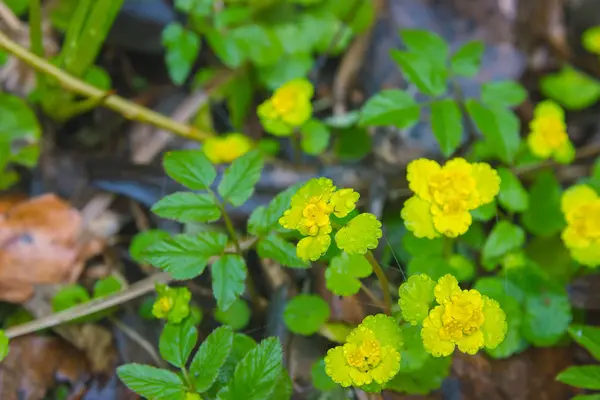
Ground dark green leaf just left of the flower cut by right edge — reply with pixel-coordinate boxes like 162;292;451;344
523;171;565;236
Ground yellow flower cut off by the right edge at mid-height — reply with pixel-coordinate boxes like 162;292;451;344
561;185;600;267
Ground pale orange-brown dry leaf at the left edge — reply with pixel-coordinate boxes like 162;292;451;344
0;194;102;303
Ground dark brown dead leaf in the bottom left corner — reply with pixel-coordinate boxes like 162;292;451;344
0;335;89;400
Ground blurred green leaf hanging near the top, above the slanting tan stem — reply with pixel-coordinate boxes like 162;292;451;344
162;22;200;85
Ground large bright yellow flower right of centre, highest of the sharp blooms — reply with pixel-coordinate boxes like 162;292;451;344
401;158;500;239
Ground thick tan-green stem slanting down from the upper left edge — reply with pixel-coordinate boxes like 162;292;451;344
0;32;212;141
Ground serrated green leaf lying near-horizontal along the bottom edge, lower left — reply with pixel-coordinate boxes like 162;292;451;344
117;364;186;400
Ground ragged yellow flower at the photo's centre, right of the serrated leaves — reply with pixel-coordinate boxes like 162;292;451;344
279;178;360;261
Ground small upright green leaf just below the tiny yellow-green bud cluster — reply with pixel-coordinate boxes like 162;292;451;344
158;318;198;368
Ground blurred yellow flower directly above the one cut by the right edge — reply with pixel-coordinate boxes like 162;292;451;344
527;100;575;164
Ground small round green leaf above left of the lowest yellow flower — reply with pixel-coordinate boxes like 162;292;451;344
283;294;330;335
